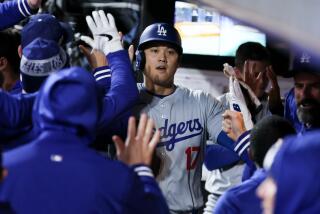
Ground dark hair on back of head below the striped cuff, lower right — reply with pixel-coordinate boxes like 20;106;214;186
250;115;296;167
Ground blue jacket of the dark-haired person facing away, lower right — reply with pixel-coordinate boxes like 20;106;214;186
214;169;267;214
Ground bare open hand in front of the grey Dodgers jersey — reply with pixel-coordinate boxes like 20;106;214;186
112;114;160;165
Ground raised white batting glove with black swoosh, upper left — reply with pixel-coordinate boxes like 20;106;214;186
81;10;123;55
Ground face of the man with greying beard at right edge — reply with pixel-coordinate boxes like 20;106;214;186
294;72;320;126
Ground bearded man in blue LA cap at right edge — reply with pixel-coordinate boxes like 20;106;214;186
284;51;320;133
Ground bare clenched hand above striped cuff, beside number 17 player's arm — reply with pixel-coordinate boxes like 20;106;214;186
222;110;246;141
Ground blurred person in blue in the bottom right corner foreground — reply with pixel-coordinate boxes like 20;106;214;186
257;130;320;214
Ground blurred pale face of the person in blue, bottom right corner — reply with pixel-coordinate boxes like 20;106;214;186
257;177;277;214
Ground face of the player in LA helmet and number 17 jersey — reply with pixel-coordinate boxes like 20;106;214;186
144;43;179;87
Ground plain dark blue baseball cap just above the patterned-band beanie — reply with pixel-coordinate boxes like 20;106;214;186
21;13;72;48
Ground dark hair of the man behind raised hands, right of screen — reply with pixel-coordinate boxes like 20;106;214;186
234;42;270;69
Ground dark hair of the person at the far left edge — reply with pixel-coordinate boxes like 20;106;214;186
0;28;21;76
